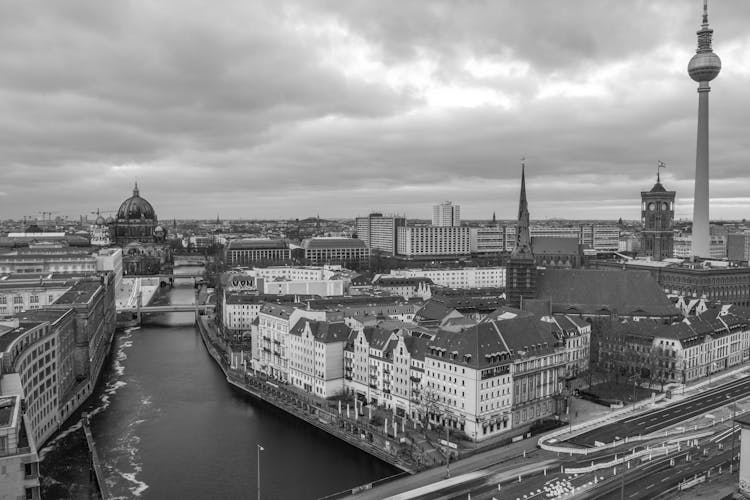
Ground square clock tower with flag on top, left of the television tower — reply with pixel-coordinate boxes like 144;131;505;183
641;168;675;260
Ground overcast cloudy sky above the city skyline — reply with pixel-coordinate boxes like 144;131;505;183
0;0;750;219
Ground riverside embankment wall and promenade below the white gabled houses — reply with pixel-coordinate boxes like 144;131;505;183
195;314;418;474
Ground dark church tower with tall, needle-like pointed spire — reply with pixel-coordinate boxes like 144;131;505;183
505;163;536;308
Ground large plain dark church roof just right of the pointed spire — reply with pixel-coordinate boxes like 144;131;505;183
536;269;679;316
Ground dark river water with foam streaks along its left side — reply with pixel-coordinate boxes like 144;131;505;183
41;271;397;499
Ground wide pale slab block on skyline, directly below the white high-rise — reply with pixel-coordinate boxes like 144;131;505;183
397;226;471;258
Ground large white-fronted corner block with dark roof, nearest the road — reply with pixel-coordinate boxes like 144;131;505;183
422;314;565;441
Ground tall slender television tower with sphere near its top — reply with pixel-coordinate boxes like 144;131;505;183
688;0;721;258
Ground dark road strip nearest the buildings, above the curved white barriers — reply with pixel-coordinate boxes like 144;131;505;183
568;377;750;447
